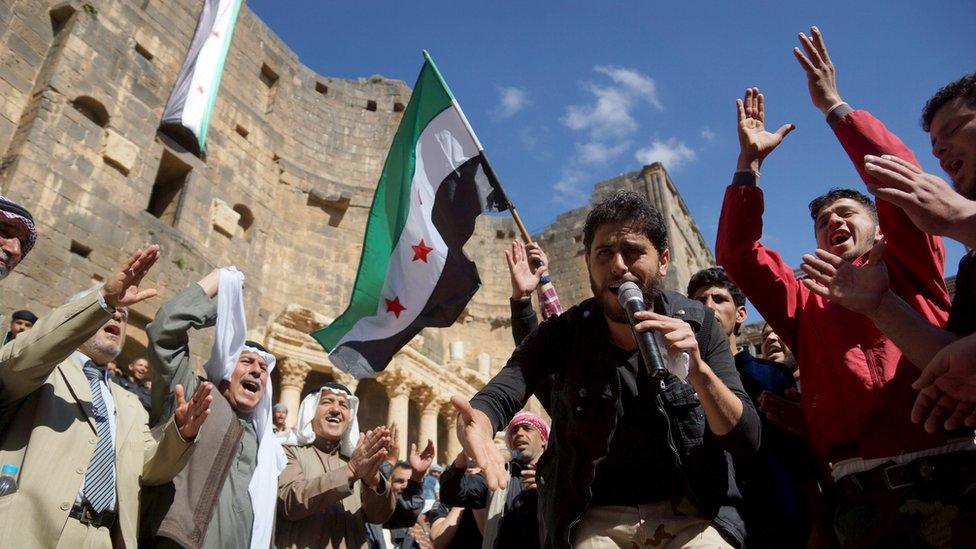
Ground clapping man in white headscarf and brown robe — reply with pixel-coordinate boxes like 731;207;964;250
275;383;396;549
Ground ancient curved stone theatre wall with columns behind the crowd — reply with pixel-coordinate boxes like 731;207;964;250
0;0;712;459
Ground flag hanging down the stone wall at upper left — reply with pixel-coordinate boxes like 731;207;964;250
160;0;243;153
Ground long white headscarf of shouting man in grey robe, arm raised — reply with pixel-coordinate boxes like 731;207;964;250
203;267;287;549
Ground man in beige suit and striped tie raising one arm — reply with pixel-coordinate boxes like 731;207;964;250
0;246;211;547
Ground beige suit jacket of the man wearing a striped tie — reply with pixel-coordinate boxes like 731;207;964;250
0;292;192;548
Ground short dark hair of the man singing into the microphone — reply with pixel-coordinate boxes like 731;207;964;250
583;190;668;253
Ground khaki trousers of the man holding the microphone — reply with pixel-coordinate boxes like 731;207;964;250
573;500;732;549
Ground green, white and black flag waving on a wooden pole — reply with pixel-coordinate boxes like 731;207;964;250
312;52;505;378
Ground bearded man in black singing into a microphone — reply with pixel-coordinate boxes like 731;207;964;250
454;191;760;547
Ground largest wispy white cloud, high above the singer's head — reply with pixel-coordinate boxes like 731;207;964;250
562;65;663;141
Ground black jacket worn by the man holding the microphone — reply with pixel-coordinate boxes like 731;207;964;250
471;291;760;547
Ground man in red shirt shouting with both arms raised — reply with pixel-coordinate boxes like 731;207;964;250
716;28;976;546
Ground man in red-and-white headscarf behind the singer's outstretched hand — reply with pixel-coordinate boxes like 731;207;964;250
441;412;549;549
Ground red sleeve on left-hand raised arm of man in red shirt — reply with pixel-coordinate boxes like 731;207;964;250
715;185;811;353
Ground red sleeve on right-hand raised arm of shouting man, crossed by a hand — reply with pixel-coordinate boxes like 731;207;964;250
833;110;949;326
